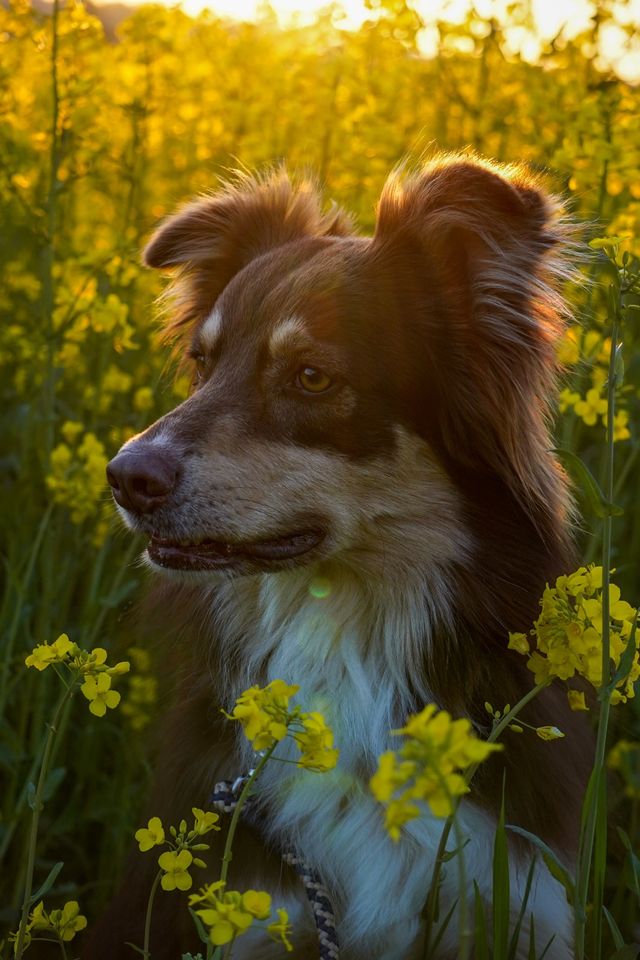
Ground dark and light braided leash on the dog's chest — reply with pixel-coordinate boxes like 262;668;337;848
210;771;340;960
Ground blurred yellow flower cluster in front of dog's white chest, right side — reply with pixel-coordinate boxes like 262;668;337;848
370;704;502;840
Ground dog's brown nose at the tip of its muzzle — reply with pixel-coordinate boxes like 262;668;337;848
107;446;180;513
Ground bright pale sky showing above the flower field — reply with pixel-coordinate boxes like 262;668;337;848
98;0;640;83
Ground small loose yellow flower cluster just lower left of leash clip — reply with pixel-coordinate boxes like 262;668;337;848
135;807;220;890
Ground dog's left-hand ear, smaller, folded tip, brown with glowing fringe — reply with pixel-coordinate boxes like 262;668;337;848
143;170;352;274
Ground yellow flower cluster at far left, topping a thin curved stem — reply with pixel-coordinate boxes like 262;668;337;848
25;633;129;717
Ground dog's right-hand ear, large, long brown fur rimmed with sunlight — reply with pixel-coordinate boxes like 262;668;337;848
373;157;571;512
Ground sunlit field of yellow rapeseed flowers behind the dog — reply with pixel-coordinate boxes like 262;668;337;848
0;0;640;960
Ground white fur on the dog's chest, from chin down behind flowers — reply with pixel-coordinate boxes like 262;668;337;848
204;565;568;960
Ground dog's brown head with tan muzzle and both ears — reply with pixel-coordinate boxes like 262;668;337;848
108;158;564;575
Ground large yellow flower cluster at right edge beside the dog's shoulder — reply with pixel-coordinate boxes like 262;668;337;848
509;565;640;710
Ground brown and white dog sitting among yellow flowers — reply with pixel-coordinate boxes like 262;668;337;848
97;157;590;960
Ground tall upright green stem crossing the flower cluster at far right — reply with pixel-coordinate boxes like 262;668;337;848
575;307;619;960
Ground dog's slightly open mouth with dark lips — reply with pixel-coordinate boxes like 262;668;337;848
147;530;325;570
